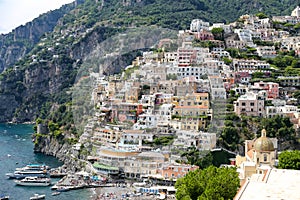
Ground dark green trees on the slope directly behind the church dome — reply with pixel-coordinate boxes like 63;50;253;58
218;114;297;151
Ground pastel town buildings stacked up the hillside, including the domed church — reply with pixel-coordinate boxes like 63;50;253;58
33;7;300;199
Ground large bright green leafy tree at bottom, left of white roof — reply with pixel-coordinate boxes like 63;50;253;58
175;166;240;200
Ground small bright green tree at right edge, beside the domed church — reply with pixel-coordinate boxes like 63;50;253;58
278;150;300;170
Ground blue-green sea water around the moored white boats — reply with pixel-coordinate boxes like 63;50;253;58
0;124;91;200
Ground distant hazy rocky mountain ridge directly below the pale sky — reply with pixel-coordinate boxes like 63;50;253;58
0;3;77;72
